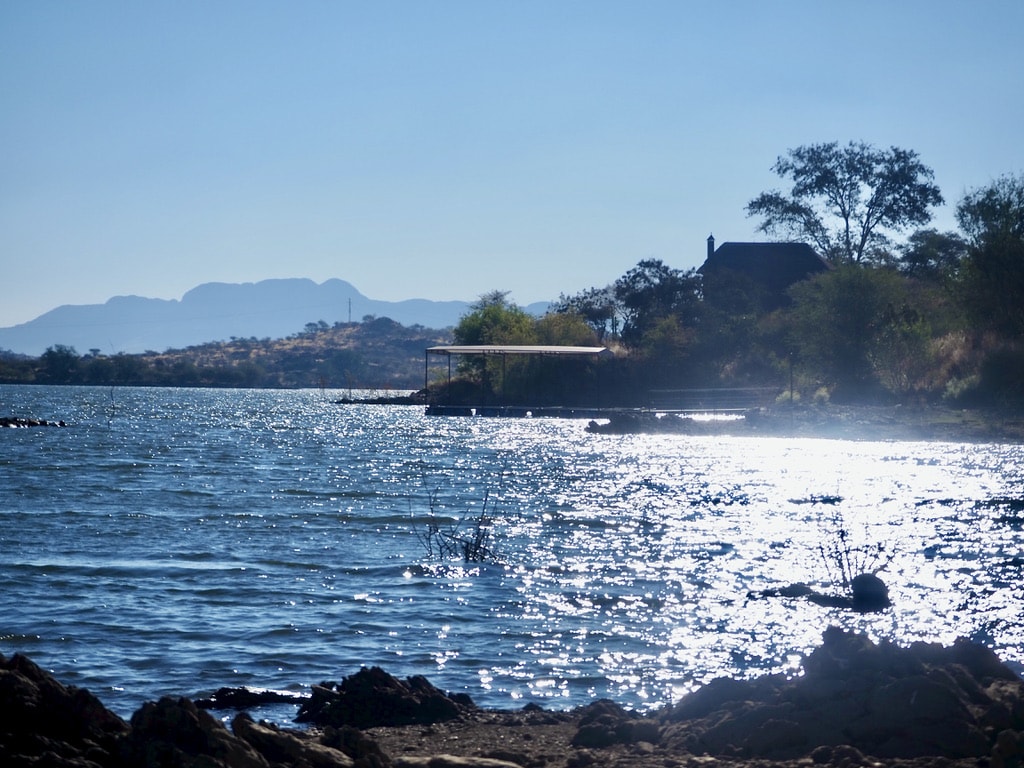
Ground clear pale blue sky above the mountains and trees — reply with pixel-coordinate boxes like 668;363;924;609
0;0;1024;327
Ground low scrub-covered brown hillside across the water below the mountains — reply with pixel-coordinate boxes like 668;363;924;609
0;317;451;389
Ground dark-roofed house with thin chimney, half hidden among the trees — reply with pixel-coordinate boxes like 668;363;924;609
697;236;830;311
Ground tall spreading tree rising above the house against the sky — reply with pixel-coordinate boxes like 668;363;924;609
746;141;942;263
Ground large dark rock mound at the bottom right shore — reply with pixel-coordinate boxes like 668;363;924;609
663;628;1024;762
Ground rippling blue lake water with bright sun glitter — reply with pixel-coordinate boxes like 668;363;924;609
0;386;1024;716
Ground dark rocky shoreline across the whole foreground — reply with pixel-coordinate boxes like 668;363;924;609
0;628;1024;768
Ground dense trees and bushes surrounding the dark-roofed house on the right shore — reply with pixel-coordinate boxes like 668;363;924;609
444;142;1024;404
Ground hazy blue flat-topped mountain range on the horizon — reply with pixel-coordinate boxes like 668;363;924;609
0;278;548;355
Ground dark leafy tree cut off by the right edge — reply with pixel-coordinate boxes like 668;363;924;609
956;174;1024;338
